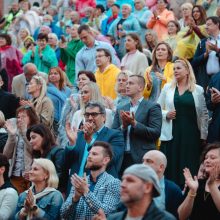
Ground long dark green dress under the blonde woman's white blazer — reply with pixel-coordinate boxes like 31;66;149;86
161;88;201;186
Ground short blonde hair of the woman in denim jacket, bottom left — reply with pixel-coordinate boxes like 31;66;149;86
33;158;59;189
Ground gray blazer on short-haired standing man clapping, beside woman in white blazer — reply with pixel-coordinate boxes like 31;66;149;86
112;99;162;163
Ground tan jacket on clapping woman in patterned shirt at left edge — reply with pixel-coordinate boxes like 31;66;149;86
3;119;33;177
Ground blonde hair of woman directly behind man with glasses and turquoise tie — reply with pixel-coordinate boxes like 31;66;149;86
80;82;104;113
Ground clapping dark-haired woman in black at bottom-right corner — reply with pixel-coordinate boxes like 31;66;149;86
178;143;220;220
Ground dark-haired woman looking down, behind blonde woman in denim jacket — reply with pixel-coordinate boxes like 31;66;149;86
26;124;66;192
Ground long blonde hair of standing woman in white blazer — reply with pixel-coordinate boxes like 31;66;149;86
171;58;196;92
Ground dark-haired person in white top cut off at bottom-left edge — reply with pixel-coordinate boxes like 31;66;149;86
0;153;18;219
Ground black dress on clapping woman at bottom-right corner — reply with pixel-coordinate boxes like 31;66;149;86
189;180;220;220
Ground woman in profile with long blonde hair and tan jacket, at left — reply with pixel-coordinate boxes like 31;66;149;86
20;76;54;127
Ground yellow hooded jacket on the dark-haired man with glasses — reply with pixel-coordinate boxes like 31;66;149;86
95;64;121;99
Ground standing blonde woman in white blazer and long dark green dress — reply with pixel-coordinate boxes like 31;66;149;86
158;59;208;186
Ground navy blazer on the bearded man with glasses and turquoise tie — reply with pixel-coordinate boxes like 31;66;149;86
65;127;125;194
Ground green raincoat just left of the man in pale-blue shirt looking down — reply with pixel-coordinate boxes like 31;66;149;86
60;39;84;84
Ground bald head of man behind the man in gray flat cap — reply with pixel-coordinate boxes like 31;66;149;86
143;150;167;178
